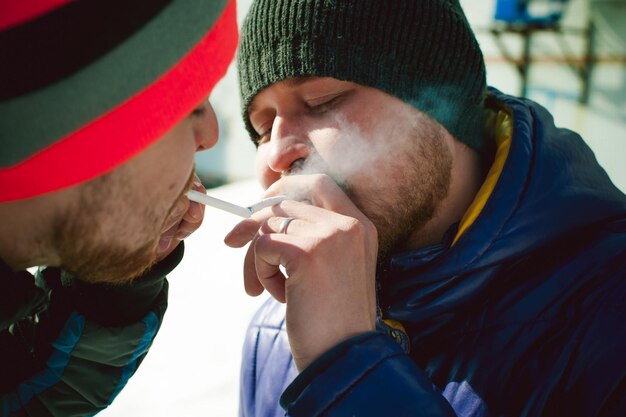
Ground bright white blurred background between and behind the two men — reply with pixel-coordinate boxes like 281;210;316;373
100;0;626;417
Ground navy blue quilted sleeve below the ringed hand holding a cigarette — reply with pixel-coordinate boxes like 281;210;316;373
281;332;456;417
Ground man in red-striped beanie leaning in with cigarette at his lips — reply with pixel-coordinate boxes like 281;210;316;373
0;0;237;416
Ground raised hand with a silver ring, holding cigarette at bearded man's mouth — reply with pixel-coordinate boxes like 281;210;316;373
224;174;378;371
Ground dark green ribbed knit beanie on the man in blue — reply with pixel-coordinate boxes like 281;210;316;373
237;0;486;150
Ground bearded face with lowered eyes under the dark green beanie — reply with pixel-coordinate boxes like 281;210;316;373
249;78;453;259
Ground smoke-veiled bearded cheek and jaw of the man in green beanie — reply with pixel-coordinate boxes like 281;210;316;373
280;98;452;257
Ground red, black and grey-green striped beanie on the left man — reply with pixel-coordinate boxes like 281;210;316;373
0;0;238;203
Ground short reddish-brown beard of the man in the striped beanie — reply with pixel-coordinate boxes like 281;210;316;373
56;168;193;284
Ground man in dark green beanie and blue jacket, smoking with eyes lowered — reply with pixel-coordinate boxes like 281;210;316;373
226;0;626;417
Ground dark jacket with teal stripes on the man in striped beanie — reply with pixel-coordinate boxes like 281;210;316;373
0;245;183;417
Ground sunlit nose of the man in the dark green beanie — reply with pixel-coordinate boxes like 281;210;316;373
266;116;311;174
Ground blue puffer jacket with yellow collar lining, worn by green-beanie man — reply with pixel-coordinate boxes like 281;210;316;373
240;90;626;417
